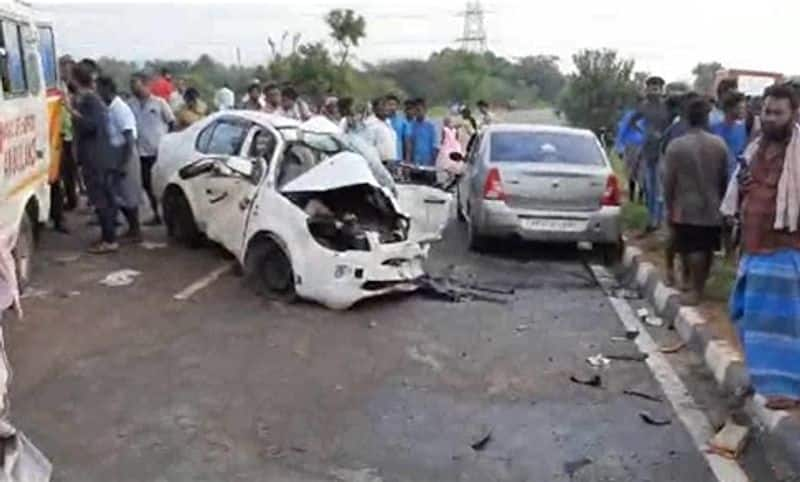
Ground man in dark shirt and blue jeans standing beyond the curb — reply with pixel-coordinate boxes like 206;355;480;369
630;77;672;233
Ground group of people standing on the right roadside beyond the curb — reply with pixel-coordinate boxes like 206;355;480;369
615;77;800;409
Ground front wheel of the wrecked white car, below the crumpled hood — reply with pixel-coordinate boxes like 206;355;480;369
244;237;297;302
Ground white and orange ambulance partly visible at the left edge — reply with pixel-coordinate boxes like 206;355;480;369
0;0;62;287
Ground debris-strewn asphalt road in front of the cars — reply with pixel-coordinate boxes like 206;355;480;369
4;213;791;482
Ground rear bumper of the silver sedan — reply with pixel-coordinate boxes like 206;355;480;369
472;201;622;243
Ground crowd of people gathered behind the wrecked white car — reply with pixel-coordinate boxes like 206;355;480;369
51;56;492;254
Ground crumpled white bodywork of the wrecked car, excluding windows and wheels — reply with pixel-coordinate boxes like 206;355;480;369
154;111;452;309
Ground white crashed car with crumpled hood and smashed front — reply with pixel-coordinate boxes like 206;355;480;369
153;111;452;309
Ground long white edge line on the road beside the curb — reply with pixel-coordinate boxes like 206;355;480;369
589;265;749;482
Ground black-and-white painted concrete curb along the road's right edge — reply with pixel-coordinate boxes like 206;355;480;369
622;247;800;472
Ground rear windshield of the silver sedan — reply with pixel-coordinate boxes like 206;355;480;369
491;132;603;166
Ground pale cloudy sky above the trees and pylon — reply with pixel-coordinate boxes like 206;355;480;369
35;0;800;80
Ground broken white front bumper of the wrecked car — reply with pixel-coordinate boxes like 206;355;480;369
295;233;430;310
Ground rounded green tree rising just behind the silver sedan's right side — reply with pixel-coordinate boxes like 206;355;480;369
560;49;637;132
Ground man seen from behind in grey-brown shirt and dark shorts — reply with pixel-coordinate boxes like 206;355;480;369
664;98;728;306
